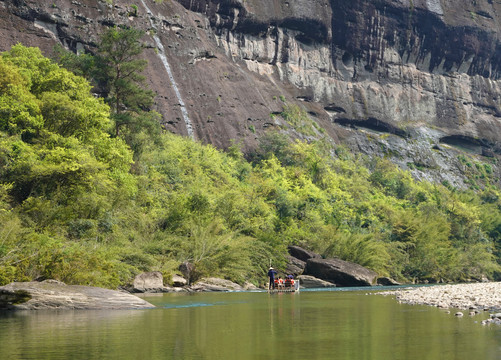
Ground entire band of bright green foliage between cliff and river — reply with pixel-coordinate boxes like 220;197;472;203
0;45;501;287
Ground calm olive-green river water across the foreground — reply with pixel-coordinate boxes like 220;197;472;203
0;290;501;360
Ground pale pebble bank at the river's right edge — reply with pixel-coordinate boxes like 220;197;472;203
375;282;501;315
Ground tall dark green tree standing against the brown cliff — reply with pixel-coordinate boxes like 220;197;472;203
55;27;161;160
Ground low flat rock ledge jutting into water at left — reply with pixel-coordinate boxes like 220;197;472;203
0;280;155;310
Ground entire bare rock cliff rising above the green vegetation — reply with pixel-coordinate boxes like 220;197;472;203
0;0;501;187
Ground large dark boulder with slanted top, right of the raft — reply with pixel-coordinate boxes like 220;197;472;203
304;258;377;286
